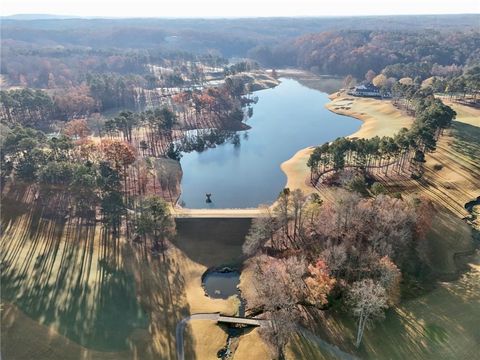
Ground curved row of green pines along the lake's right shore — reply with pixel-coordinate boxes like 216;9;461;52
307;84;456;185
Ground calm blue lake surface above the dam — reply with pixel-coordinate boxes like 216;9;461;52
180;79;360;208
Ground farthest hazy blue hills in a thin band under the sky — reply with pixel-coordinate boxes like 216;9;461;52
0;14;480;57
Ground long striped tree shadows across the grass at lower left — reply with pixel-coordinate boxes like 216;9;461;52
0;187;193;359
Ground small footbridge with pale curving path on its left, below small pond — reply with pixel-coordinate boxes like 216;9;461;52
175;313;270;360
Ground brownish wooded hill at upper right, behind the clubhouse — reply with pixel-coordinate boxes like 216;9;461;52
249;29;480;79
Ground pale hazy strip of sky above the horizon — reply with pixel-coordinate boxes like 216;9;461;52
0;0;480;17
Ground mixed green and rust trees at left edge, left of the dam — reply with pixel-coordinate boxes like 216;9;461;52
0;121;178;252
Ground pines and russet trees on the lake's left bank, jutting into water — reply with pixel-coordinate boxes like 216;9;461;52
103;79;254;160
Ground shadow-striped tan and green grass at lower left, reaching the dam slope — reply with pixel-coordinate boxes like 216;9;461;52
1;188;248;360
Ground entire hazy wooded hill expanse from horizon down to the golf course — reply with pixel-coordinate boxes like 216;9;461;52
0;15;480;90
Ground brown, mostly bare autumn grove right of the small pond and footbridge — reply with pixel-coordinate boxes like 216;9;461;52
244;189;433;345
